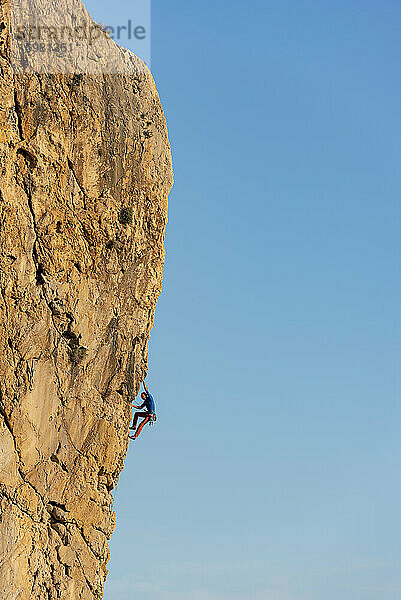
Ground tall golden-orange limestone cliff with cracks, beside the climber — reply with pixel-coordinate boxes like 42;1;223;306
0;0;172;600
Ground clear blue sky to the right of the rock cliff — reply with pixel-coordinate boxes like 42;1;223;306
86;0;401;600
